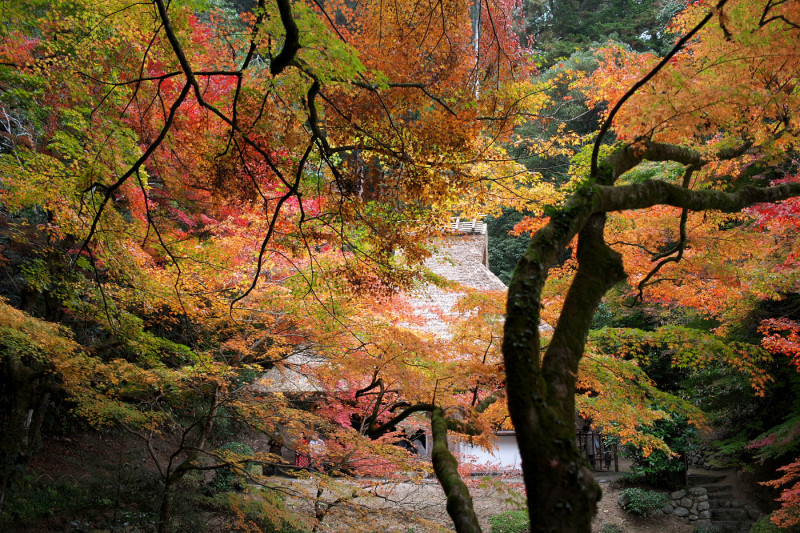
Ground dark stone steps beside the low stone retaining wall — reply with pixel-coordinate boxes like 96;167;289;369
689;474;761;533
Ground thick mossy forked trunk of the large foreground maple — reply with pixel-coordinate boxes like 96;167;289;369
503;209;625;533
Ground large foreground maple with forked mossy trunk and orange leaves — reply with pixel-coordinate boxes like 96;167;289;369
503;1;798;531
